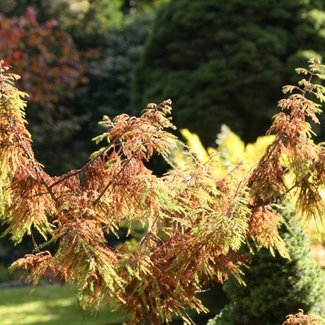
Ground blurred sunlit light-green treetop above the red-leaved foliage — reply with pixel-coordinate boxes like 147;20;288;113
0;0;123;50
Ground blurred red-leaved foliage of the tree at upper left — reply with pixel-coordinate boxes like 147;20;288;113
0;7;83;122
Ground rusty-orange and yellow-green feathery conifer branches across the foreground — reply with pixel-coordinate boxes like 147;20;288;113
0;61;325;324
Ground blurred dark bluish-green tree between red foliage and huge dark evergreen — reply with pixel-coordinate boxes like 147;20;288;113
82;13;154;143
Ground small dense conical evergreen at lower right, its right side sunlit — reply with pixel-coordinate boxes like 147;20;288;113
208;208;325;325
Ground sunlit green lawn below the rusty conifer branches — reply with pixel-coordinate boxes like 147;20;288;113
0;285;126;325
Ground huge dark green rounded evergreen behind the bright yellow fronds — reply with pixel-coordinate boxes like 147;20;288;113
133;0;325;144
